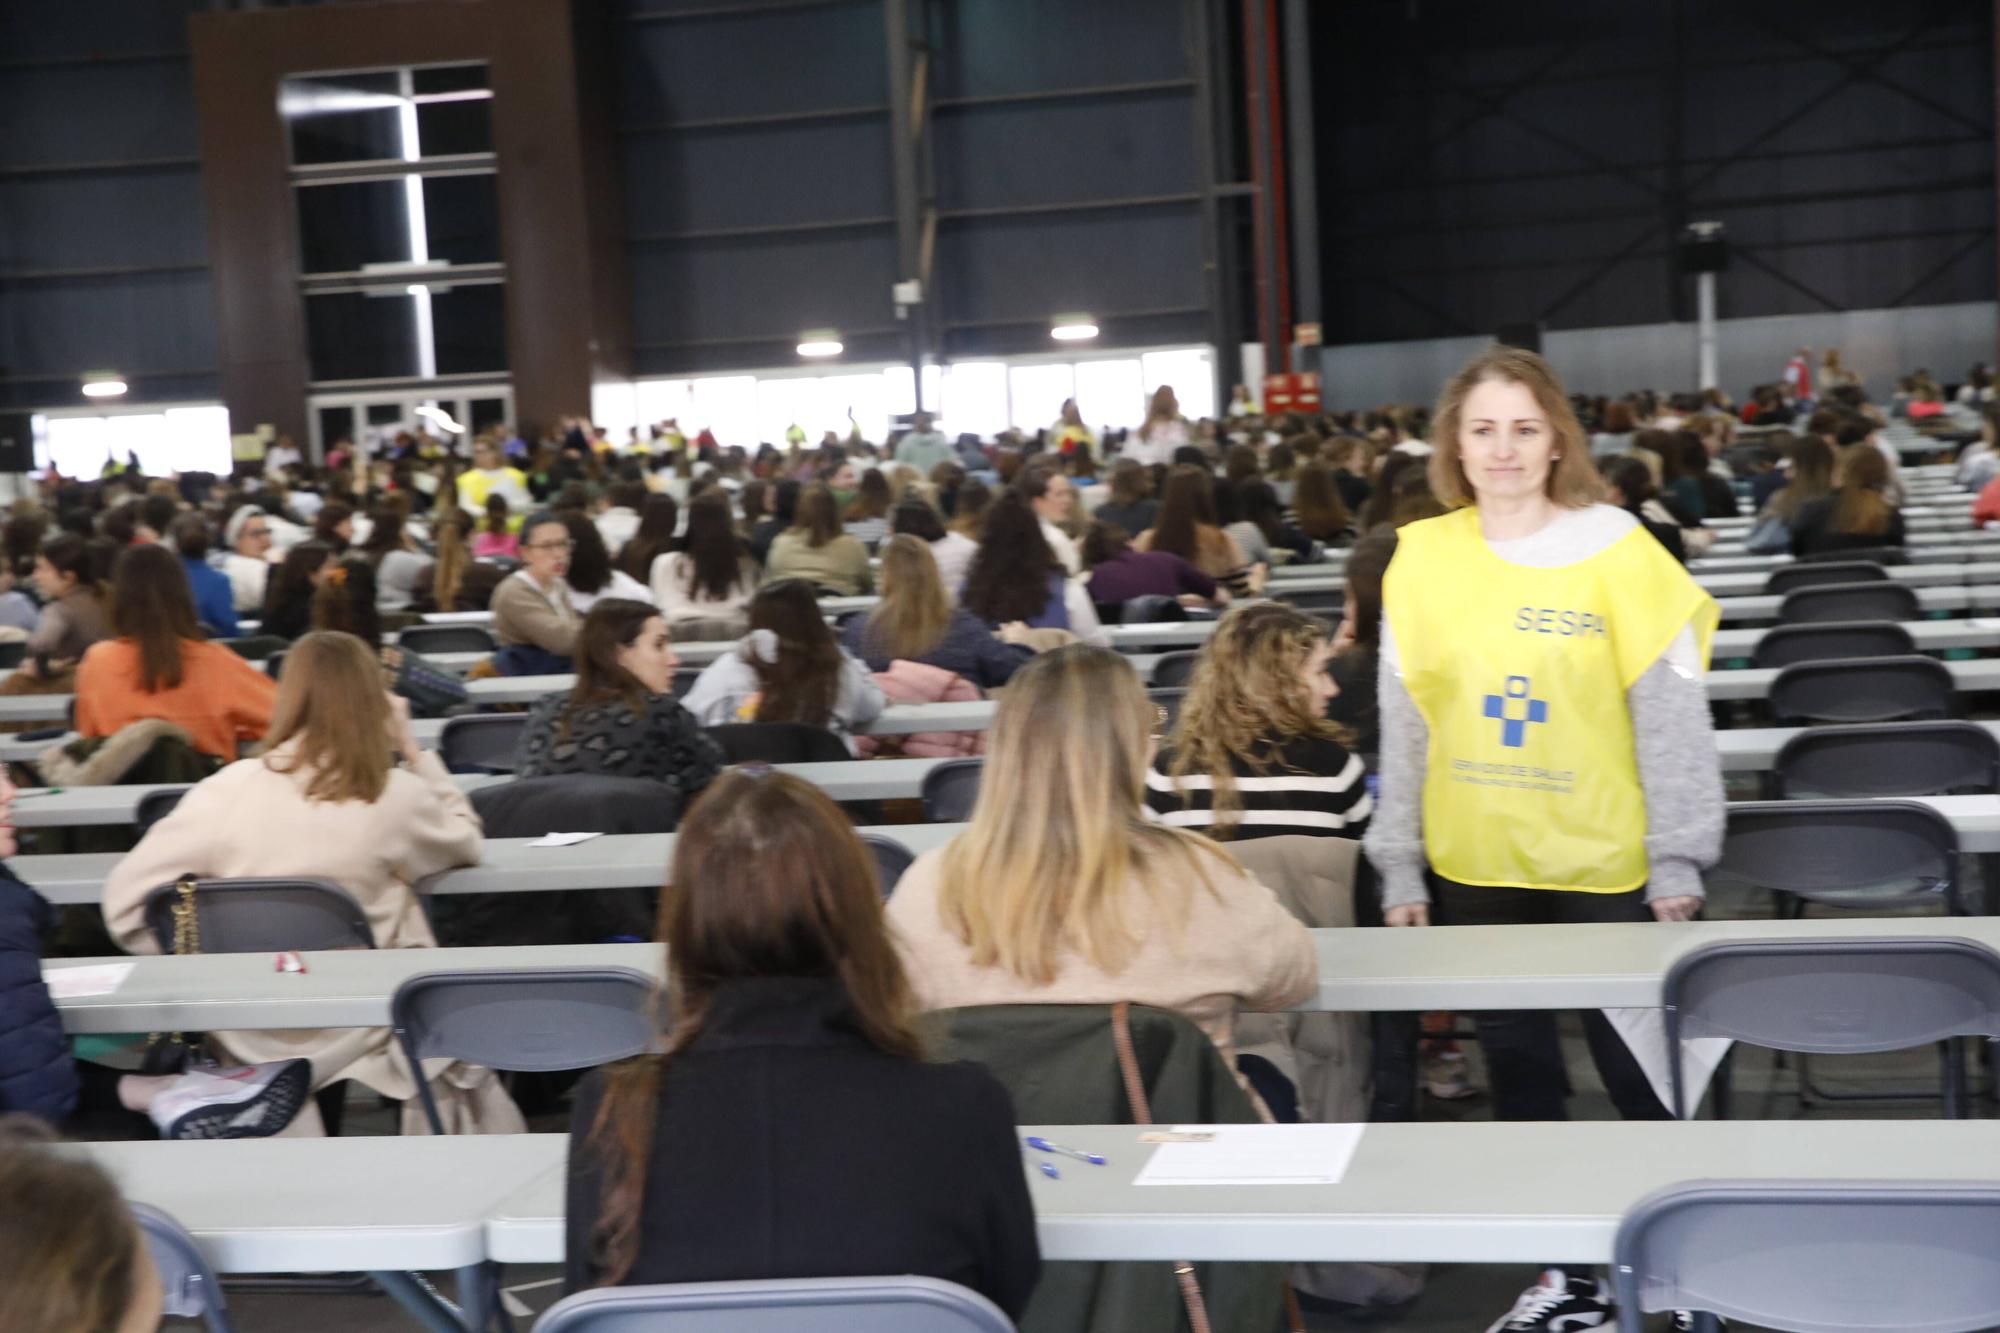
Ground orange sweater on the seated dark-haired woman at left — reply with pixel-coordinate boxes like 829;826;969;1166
76;638;278;763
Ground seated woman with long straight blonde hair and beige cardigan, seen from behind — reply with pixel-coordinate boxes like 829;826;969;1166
888;644;1318;1067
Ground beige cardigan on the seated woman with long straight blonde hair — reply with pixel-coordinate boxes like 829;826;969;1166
888;847;1320;1069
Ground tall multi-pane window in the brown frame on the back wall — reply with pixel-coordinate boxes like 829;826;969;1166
278;64;506;386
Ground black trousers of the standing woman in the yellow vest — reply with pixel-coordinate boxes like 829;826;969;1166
1430;875;1670;1121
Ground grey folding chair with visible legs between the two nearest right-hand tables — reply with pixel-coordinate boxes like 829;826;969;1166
1660;939;2000;1119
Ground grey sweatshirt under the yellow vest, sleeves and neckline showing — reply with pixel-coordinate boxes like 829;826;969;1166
1362;504;1726;909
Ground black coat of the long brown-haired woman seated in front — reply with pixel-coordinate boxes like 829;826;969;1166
566;977;1042;1317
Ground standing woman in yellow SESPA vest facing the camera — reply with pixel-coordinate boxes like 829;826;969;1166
1364;346;1724;1329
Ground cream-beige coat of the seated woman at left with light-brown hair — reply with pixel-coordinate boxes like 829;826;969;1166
104;749;526;1133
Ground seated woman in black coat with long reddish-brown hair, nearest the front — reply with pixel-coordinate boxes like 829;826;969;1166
566;773;1040;1317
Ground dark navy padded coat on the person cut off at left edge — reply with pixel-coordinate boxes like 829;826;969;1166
0;867;76;1123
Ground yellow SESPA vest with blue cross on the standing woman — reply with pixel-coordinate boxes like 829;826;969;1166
1382;508;1722;893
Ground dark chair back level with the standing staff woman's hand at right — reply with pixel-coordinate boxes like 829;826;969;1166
1704;801;1964;915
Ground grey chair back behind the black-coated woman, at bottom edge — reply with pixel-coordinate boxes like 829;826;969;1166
534;1277;1014;1333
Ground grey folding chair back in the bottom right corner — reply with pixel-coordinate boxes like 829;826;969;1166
1612;1181;2000;1333
